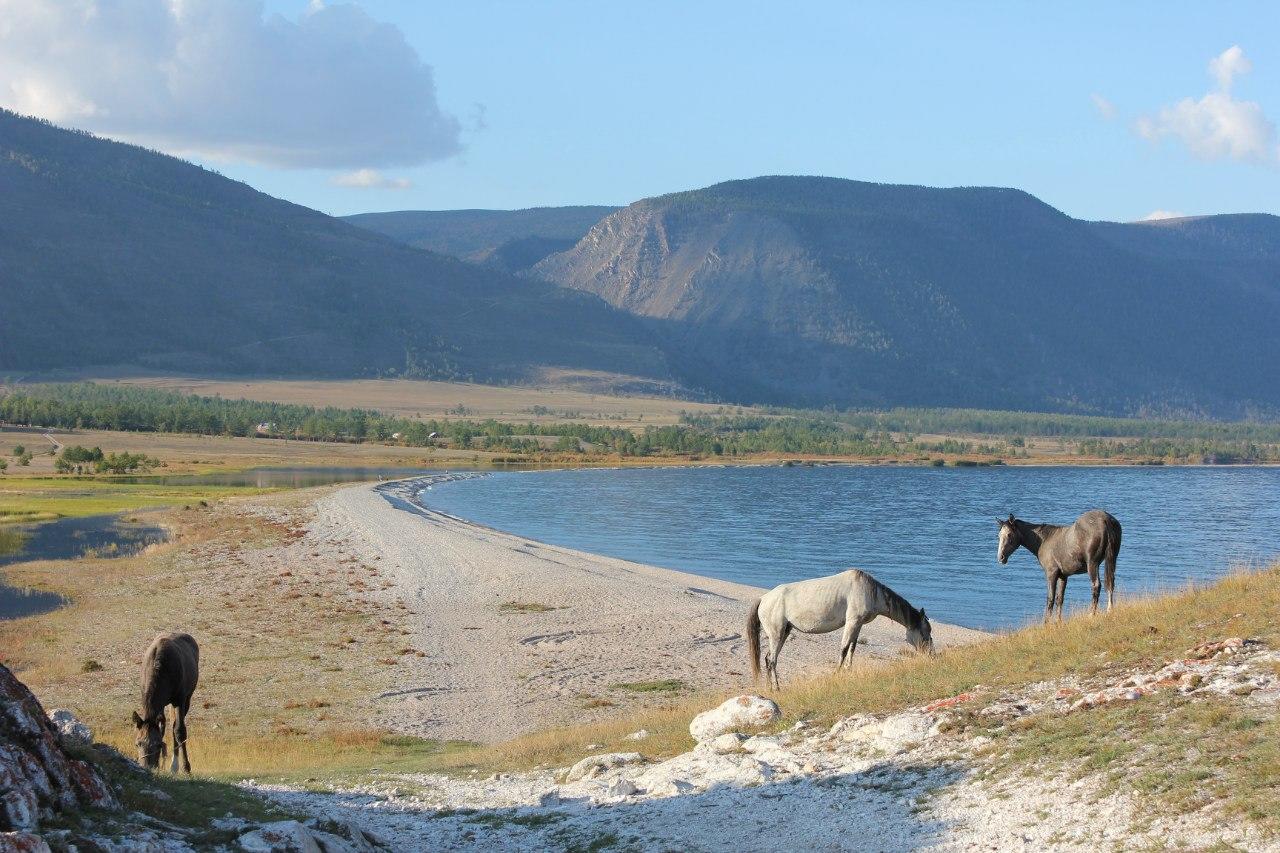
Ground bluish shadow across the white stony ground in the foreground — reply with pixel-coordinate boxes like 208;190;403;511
262;761;968;852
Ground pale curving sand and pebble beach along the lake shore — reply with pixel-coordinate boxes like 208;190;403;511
308;478;984;742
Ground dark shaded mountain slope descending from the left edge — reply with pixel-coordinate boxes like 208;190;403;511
0;111;667;379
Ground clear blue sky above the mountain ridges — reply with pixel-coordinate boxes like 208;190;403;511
0;0;1280;220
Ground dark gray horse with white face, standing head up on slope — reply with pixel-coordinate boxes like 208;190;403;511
996;510;1120;622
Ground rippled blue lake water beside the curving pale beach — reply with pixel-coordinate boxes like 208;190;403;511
421;466;1280;629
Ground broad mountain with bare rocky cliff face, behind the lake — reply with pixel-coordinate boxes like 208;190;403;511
530;177;1280;415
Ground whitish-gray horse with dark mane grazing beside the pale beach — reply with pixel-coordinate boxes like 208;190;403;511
746;569;933;688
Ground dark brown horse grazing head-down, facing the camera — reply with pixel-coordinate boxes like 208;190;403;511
133;634;200;774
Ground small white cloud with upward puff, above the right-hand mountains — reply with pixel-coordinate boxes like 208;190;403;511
1134;46;1280;164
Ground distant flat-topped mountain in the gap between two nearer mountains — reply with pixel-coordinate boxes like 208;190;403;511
343;206;617;273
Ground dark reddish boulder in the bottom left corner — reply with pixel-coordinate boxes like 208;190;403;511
0;665;120;830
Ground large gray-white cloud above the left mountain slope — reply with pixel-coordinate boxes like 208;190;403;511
0;0;461;169
